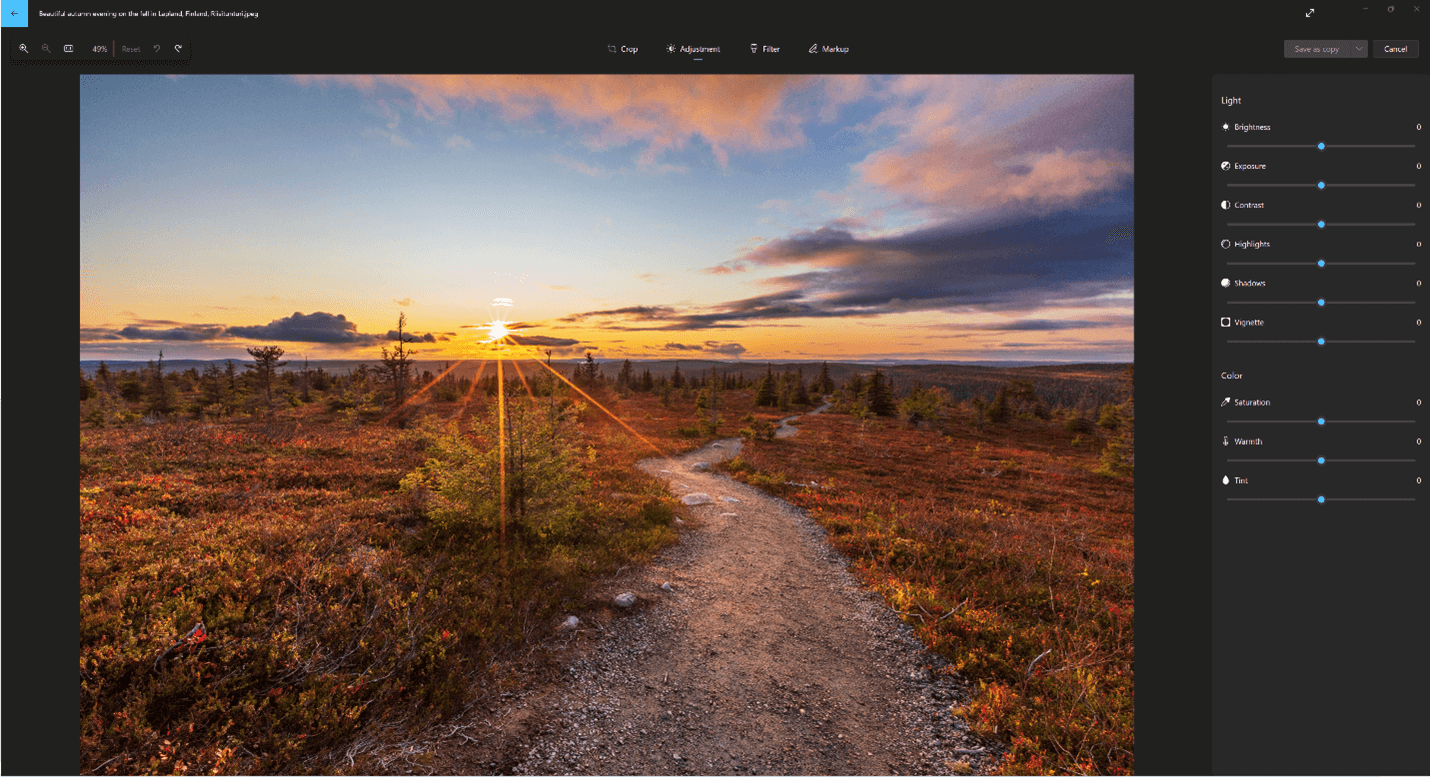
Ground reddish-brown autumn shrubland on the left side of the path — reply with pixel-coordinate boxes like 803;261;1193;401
79;392;694;774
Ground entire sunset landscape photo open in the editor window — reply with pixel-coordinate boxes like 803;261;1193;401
79;74;1135;774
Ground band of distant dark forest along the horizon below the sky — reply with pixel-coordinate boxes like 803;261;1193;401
80;356;1128;416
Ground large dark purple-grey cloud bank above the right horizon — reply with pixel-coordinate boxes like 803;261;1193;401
562;189;1133;331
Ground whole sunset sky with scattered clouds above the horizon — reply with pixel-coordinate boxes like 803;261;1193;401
80;74;1133;362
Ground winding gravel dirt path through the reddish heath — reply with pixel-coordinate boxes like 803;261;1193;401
428;408;991;774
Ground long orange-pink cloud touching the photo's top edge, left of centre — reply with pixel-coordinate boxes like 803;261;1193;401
293;74;867;175
